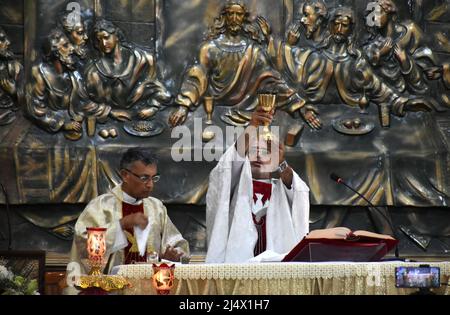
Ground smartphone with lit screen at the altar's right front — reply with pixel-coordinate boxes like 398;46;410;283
395;267;441;288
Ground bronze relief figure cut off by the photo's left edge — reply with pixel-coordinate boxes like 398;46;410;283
0;27;23;126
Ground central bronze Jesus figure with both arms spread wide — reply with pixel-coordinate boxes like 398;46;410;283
169;2;321;129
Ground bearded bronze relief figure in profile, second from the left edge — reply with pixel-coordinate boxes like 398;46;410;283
27;29;111;140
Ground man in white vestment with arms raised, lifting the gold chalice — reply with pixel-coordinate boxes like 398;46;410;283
206;108;309;263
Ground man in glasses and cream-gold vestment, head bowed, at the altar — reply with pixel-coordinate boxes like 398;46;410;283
65;148;189;286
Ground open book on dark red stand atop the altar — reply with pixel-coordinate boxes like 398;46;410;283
282;227;398;262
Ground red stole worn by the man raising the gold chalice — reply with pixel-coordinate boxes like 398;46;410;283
252;180;272;257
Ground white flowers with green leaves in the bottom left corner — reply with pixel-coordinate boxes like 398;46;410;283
0;264;39;295
